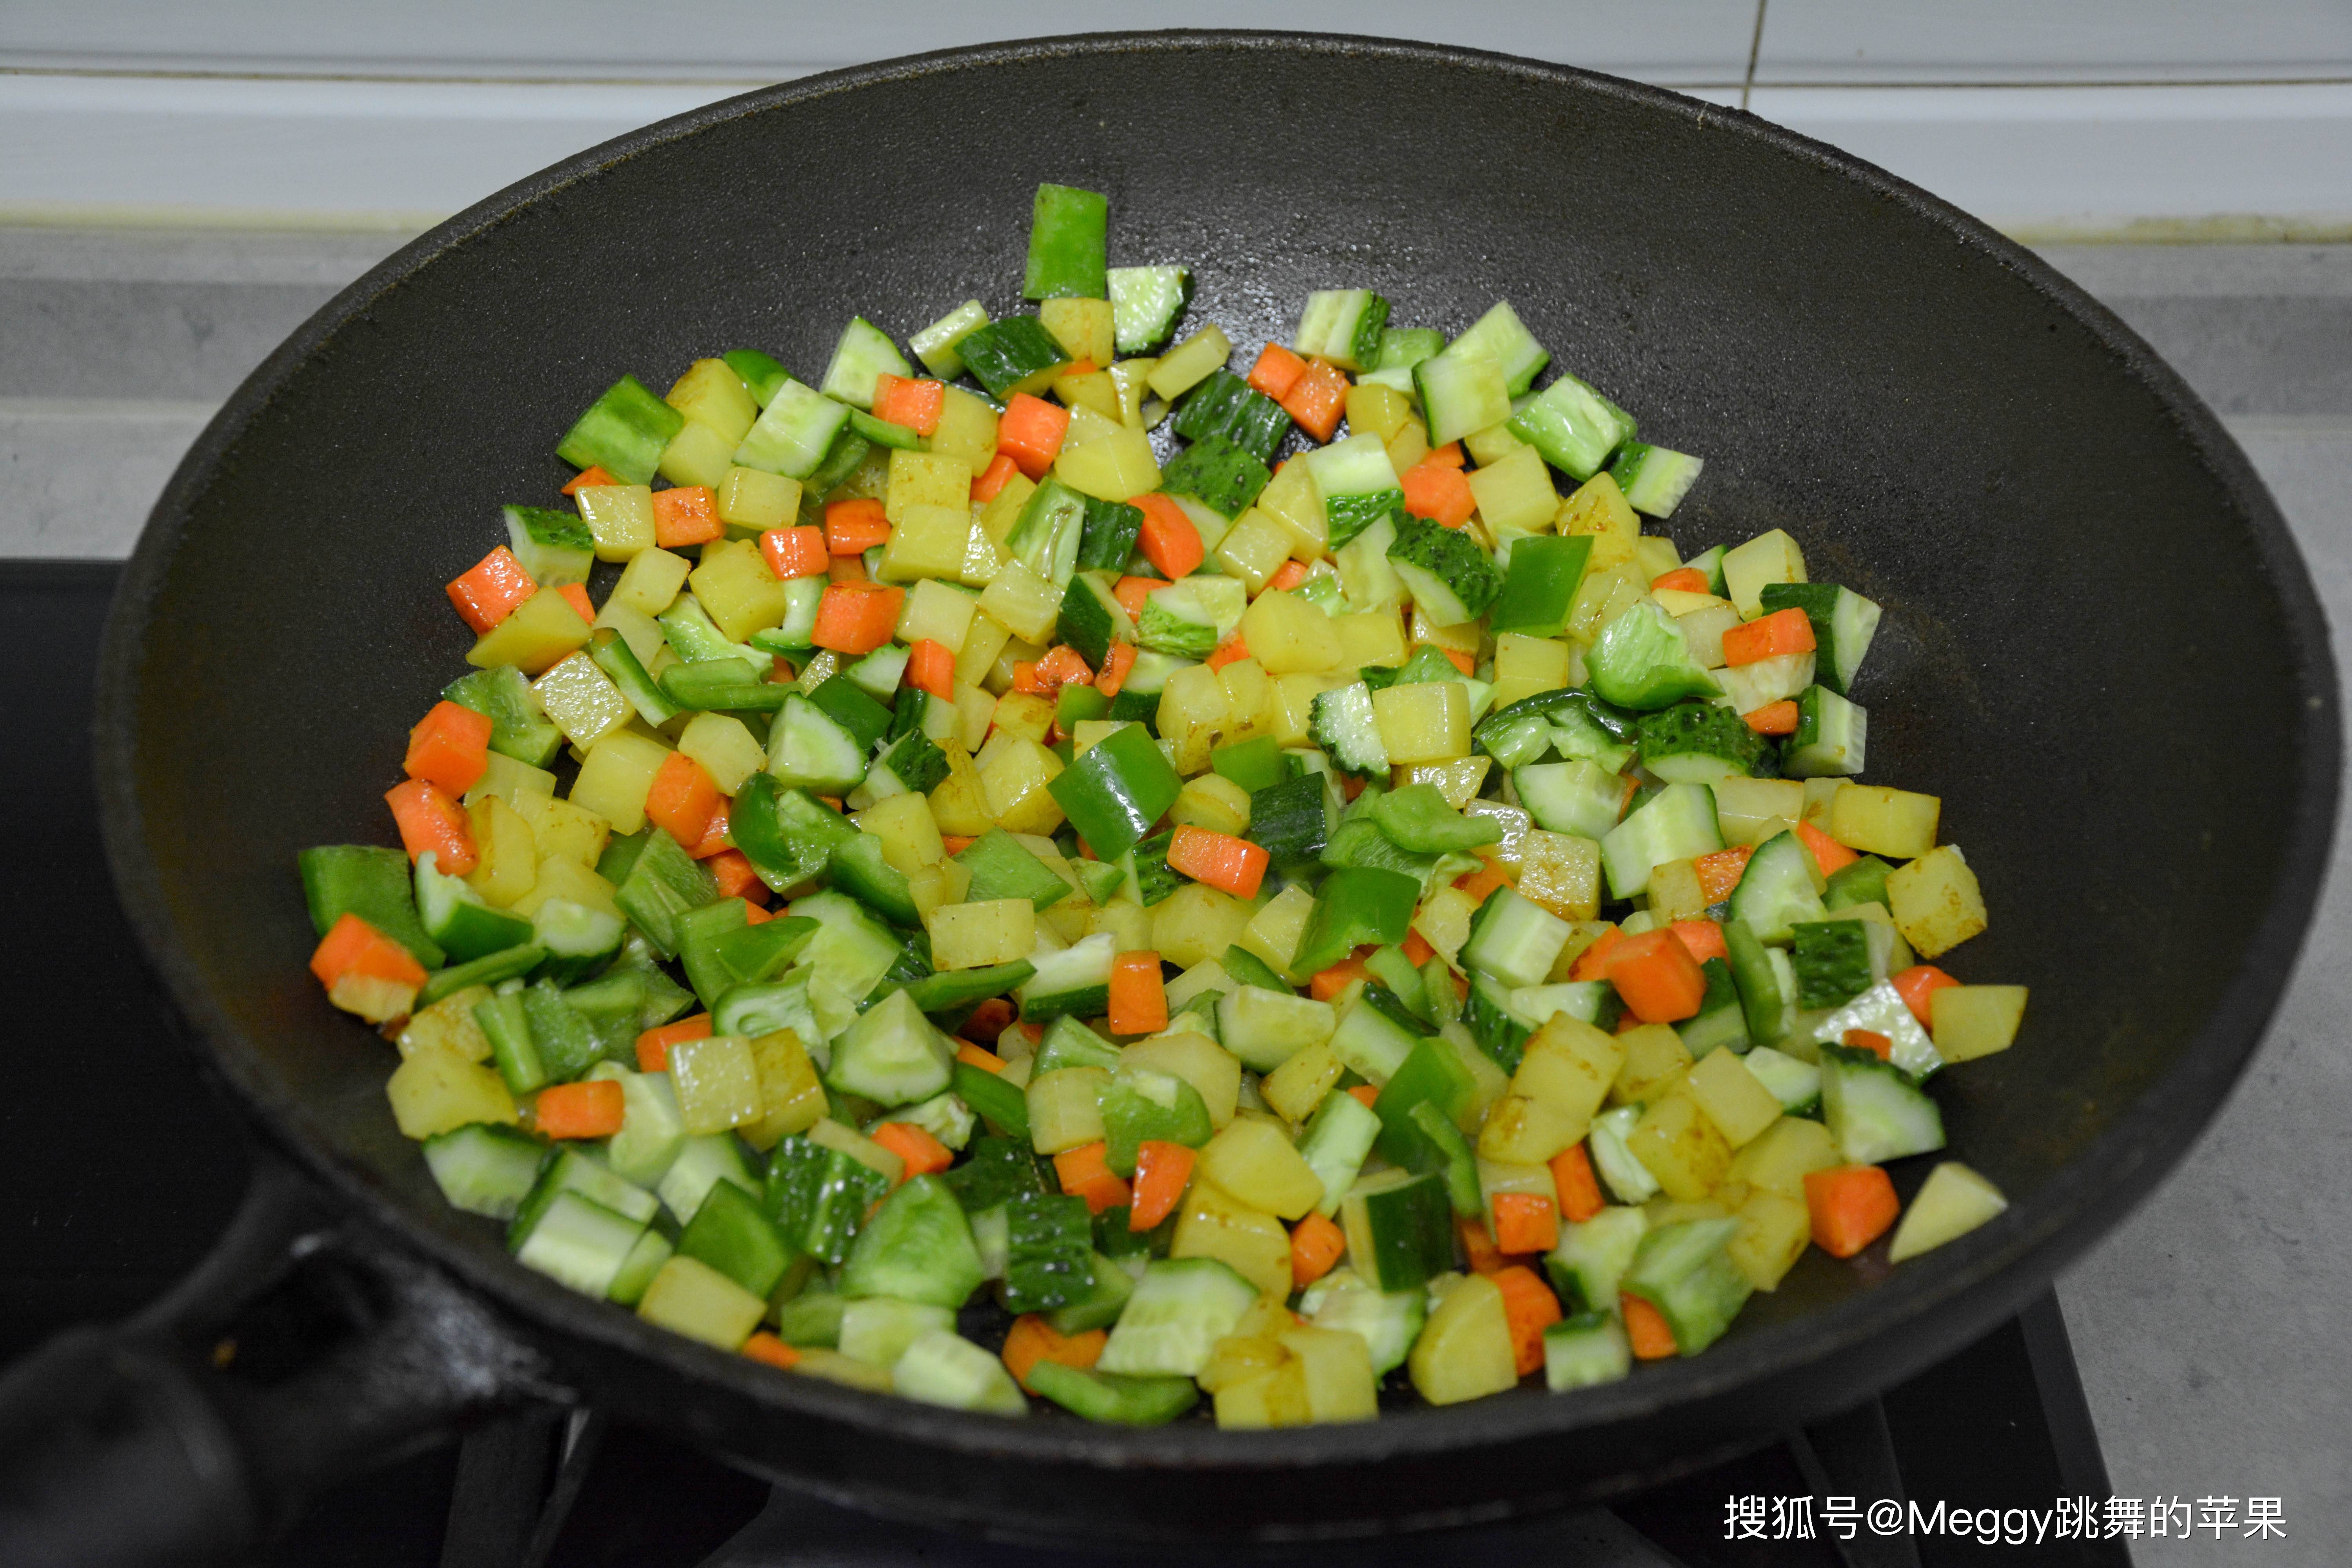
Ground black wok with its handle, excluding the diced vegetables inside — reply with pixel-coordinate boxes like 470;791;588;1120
5;33;2338;1561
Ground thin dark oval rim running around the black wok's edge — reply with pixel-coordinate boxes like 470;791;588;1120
94;31;2343;1469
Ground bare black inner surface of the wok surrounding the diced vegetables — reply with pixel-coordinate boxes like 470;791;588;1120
103;38;2333;1504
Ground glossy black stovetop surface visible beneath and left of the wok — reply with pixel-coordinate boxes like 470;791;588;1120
0;562;2129;1568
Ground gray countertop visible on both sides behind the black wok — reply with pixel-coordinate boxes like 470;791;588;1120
0;228;2352;1563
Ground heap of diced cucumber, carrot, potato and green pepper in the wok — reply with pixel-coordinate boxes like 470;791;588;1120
301;186;2025;1427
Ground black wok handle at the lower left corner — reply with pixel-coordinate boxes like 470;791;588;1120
0;1152;569;1568
